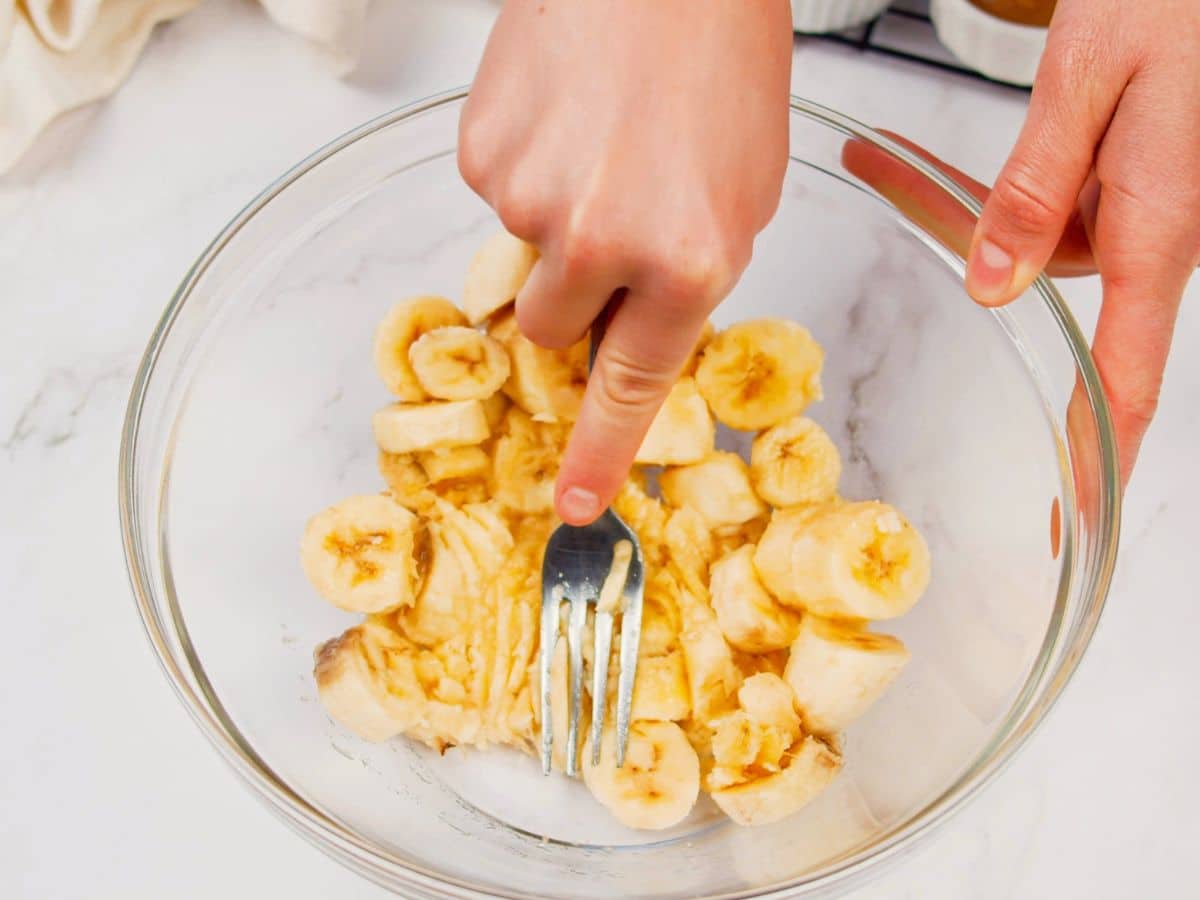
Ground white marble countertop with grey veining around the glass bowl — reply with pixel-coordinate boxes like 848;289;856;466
0;0;1200;900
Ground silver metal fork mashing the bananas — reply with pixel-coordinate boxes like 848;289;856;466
538;311;644;776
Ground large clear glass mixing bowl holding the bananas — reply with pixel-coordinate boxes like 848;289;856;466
120;91;1120;898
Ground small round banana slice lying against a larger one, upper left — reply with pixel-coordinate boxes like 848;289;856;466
408;325;510;400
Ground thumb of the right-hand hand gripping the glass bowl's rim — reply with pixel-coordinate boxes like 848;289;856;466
966;20;1127;306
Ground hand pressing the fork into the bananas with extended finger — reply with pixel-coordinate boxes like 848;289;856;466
458;0;792;524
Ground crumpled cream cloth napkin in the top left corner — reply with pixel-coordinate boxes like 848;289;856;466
0;0;368;173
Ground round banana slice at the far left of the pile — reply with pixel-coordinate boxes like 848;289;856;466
300;494;419;612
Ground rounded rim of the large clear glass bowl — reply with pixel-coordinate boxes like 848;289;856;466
118;86;1121;900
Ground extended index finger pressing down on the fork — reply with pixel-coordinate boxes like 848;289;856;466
554;292;706;526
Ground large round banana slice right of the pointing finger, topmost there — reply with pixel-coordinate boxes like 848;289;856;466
696;319;824;431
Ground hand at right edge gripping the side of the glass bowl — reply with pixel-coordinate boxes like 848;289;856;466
967;0;1200;482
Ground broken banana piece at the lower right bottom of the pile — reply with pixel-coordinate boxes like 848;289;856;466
713;737;841;826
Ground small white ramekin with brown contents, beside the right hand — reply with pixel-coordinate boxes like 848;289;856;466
930;0;1046;86
